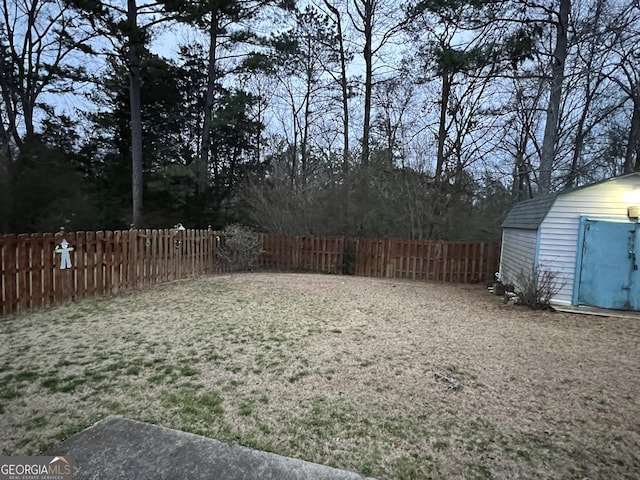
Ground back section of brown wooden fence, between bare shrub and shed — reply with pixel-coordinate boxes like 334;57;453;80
261;234;500;283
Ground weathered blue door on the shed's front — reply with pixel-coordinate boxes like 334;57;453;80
578;220;640;310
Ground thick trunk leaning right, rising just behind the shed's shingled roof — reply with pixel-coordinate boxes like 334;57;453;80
538;0;571;195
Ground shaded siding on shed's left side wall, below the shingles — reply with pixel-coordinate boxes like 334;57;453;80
500;228;537;286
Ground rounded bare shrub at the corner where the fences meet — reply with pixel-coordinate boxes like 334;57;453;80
216;224;263;272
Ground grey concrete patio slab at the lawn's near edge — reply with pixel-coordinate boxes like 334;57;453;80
45;416;372;480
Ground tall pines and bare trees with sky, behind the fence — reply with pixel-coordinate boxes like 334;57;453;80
0;0;640;241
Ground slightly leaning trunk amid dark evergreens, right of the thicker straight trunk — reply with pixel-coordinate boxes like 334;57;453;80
196;10;220;194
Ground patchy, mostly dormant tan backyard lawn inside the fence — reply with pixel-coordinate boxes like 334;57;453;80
0;273;640;480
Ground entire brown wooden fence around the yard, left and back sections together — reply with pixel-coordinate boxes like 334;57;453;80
0;229;500;315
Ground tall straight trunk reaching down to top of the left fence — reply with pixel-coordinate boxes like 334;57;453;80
127;0;143;227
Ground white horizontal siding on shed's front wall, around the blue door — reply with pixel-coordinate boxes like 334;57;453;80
536;176;640;305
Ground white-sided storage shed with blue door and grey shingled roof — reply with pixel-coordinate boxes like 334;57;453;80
500;173;640;311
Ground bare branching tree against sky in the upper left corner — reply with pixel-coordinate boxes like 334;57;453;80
0;0;96;152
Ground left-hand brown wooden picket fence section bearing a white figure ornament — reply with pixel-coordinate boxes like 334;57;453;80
0;229;220;315
